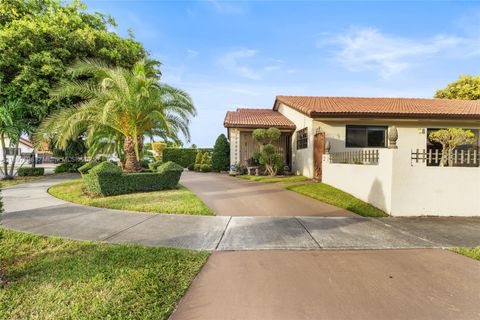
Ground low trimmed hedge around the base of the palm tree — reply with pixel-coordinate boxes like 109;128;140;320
82;162;183;196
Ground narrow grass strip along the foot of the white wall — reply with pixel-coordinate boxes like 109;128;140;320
285;183;387;217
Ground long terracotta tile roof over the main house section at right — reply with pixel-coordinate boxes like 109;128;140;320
274;96;480;119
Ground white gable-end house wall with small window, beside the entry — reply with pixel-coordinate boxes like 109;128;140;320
278;104;319;178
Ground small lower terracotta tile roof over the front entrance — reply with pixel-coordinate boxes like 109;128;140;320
223;108;295;130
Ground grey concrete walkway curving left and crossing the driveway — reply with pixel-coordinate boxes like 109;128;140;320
2;176;480;251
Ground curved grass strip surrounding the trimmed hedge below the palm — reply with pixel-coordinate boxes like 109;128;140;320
48;179;213;215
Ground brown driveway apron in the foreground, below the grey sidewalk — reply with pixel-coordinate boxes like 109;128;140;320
170;249;480;320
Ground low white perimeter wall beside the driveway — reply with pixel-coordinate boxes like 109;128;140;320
322;139;480;216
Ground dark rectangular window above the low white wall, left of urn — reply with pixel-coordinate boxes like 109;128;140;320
345;126;387;148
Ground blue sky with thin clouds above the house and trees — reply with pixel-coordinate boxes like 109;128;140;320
86;0;480;147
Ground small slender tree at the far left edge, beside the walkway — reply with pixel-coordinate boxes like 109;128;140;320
0;100;33;180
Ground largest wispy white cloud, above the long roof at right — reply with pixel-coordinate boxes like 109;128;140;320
317;28;470;78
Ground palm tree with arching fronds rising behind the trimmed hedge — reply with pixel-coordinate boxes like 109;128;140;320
35;60;196;172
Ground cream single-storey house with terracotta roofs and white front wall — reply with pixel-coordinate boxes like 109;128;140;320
224;96;480;216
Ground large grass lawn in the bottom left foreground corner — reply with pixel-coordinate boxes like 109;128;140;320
0;229;208;319
